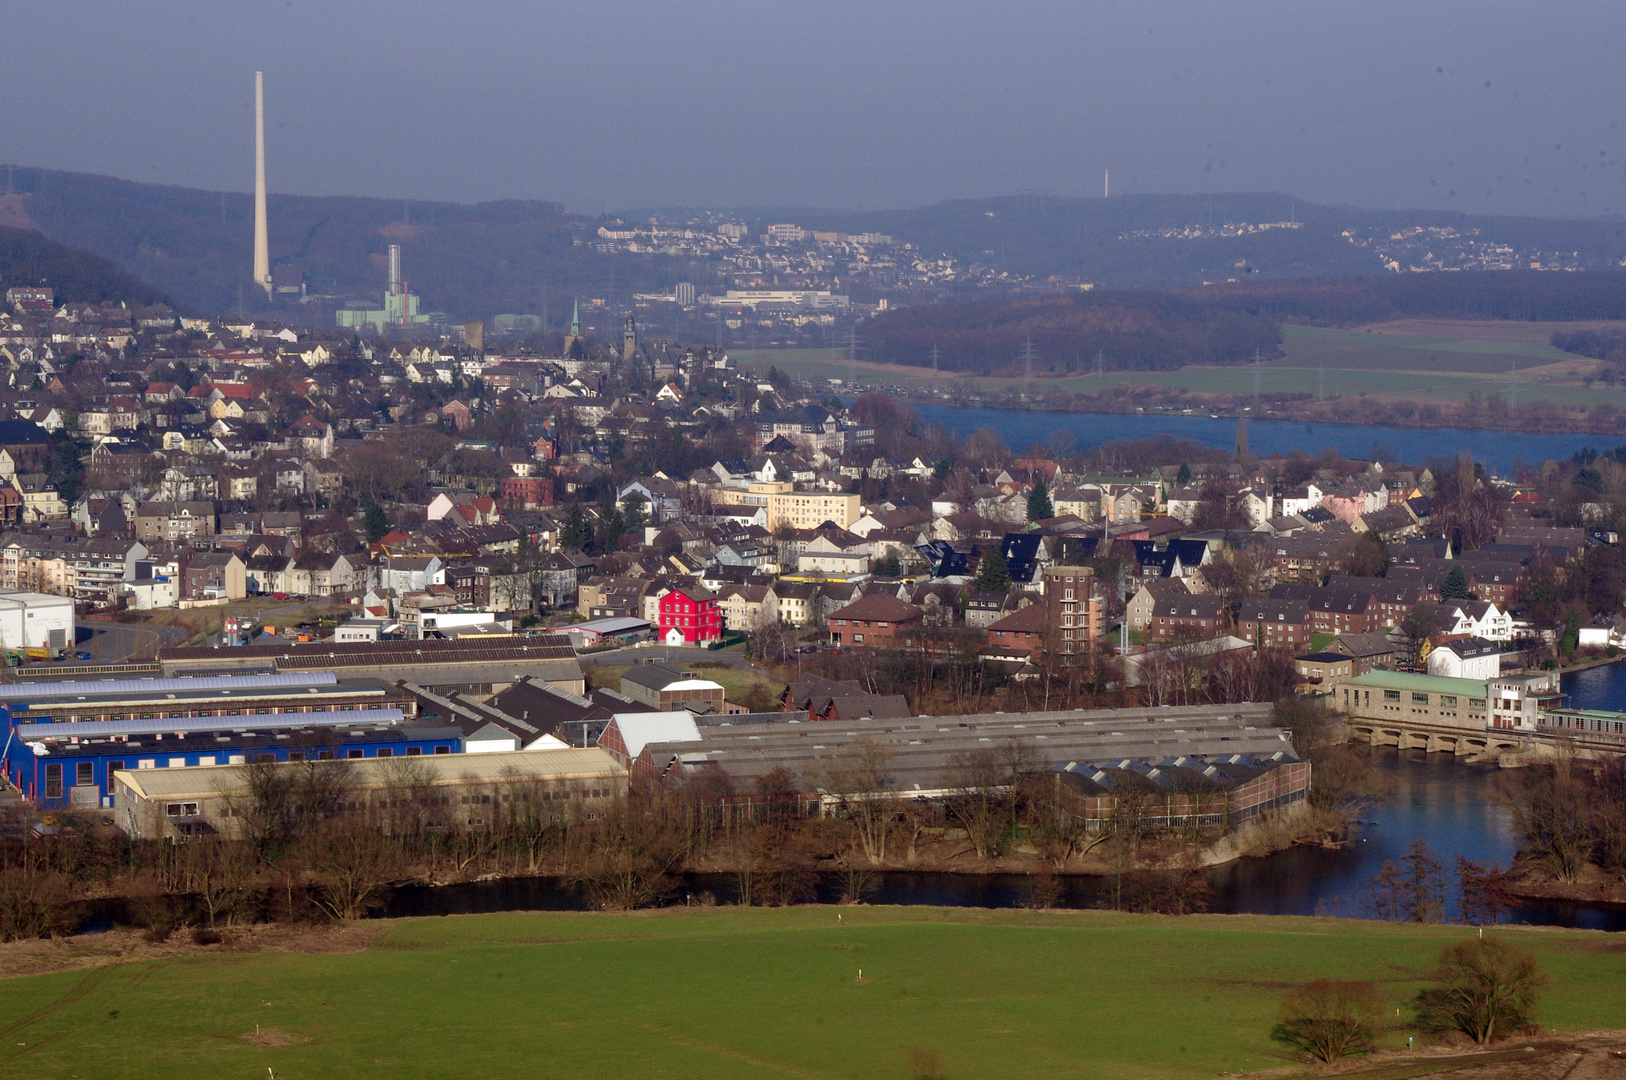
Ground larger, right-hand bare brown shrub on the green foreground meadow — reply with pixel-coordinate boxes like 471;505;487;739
1418;937;1546;1043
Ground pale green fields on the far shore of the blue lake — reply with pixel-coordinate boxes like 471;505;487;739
735;319;1626;408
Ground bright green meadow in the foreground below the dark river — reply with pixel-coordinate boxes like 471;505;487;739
0;908;1626;1080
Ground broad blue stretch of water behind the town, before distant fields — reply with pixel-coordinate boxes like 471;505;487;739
912;403;1619;475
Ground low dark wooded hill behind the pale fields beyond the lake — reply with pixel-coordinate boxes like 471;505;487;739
863;270;1626;374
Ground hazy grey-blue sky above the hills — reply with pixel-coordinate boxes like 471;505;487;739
0;0;1626;216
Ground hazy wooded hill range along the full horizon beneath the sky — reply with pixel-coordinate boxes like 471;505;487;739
9;168;1626;324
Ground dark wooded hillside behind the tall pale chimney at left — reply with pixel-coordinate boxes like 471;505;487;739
0;168;706;324
